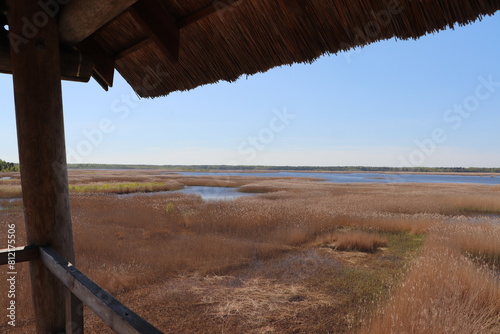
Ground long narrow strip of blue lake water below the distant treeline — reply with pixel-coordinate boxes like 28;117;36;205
179;172;500;185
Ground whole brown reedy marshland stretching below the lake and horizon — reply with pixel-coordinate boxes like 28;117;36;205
0;170;500;333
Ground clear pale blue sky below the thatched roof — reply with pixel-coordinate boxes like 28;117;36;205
0;13;500;167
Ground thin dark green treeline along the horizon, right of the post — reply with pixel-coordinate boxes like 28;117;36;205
68;164;500;173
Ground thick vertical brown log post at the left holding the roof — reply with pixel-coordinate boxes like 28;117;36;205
8;0;83;334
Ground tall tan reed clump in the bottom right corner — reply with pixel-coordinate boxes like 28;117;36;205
361;246;500;334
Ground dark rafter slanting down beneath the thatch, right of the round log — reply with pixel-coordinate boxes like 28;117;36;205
129;0;180;64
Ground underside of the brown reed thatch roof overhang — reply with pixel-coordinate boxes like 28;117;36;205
87;0;500;97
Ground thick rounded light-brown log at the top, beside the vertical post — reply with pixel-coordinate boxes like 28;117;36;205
59;0;137;46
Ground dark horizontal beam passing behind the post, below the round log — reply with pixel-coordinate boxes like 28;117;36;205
0;45;94;82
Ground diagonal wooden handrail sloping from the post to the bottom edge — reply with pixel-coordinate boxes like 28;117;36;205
40;247;162;334
